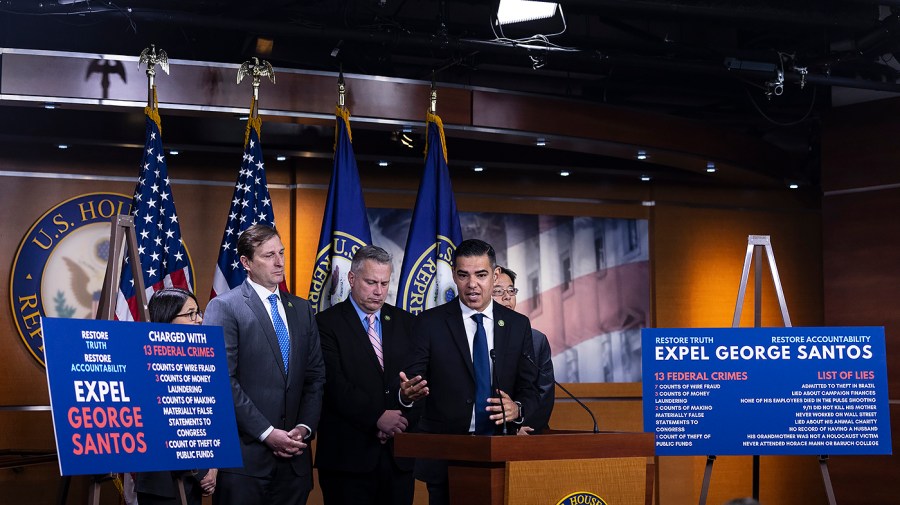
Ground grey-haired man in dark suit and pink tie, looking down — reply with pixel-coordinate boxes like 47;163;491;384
316;246;418;505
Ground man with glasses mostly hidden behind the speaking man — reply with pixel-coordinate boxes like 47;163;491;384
493;266;556;435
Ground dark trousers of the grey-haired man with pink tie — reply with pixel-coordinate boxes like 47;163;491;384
319;446;415;505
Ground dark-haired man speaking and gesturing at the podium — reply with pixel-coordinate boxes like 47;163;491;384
400;240;537;505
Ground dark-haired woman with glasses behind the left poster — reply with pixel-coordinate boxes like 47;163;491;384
134;288;217;505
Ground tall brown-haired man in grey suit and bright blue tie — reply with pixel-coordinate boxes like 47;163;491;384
203;225;325;505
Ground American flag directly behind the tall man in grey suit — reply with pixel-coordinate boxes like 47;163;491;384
209;117;278;300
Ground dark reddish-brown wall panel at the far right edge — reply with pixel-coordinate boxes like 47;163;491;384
822;99;900;505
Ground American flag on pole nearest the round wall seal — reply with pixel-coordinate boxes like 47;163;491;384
116;107;194;321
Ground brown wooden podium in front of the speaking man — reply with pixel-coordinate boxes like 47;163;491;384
394;431;654;505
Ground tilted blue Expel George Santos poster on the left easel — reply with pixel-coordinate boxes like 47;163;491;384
42;317;243;475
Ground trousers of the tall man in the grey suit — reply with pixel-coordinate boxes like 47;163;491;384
213;459;312;505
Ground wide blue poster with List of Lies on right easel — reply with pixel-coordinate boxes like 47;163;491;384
641;327;891;456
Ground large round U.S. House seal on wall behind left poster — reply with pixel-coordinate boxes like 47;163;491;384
9;193;131;365
